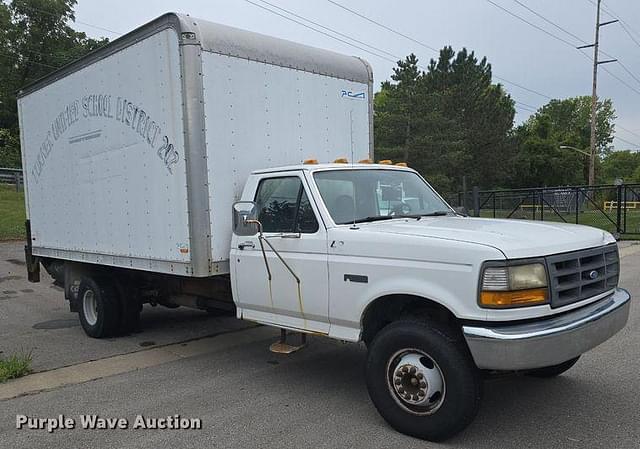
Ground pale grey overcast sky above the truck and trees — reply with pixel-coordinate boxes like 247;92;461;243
73;0;640;150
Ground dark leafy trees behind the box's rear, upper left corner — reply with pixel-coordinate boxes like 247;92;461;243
0;0;107;166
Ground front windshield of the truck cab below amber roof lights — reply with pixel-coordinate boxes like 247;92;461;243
313;169;453;224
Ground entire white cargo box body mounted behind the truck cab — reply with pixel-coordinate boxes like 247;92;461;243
18;14;372;277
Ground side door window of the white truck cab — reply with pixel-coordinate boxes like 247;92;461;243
255;176;319;234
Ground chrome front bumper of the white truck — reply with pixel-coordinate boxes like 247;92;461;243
462;288;631;371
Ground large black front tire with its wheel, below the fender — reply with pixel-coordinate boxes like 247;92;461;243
366;320;482;441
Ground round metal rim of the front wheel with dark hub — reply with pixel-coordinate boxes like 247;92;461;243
387;349;446;415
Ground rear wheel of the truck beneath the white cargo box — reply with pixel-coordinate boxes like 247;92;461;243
78;277;120;338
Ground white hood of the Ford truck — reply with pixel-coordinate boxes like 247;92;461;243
361;216;615;259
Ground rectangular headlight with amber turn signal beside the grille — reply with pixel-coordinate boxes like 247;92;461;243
479;263;549;308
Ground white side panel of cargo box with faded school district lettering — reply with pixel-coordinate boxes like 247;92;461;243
19;28;191;274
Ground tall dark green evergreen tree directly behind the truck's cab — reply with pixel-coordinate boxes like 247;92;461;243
374;47;515;191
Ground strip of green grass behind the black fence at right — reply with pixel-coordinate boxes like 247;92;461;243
480;208;640;240
